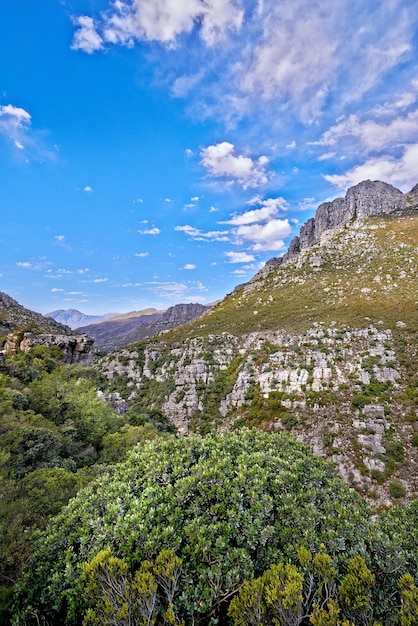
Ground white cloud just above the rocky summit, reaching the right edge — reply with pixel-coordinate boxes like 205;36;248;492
324;143;418;192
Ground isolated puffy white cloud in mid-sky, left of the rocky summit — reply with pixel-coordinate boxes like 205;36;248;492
200;141;269;189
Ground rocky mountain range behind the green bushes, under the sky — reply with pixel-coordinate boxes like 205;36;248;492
0;181;418;505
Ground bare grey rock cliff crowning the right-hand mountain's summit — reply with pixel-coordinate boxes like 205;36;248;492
250;180;418;280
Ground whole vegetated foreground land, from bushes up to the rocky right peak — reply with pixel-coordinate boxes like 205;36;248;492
0;181;418;626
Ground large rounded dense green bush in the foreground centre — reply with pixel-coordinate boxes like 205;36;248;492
16;430;370;626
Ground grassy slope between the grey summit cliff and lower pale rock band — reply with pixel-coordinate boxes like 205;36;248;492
164;215;418;343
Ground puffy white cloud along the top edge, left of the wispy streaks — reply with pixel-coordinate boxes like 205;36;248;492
72;0;244;54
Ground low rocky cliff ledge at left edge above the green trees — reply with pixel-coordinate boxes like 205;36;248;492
4;332;94;365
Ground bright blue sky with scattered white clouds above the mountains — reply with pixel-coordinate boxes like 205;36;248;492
0;0;418;314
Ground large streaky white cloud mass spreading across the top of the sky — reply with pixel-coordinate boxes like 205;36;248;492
72;0;417;132
